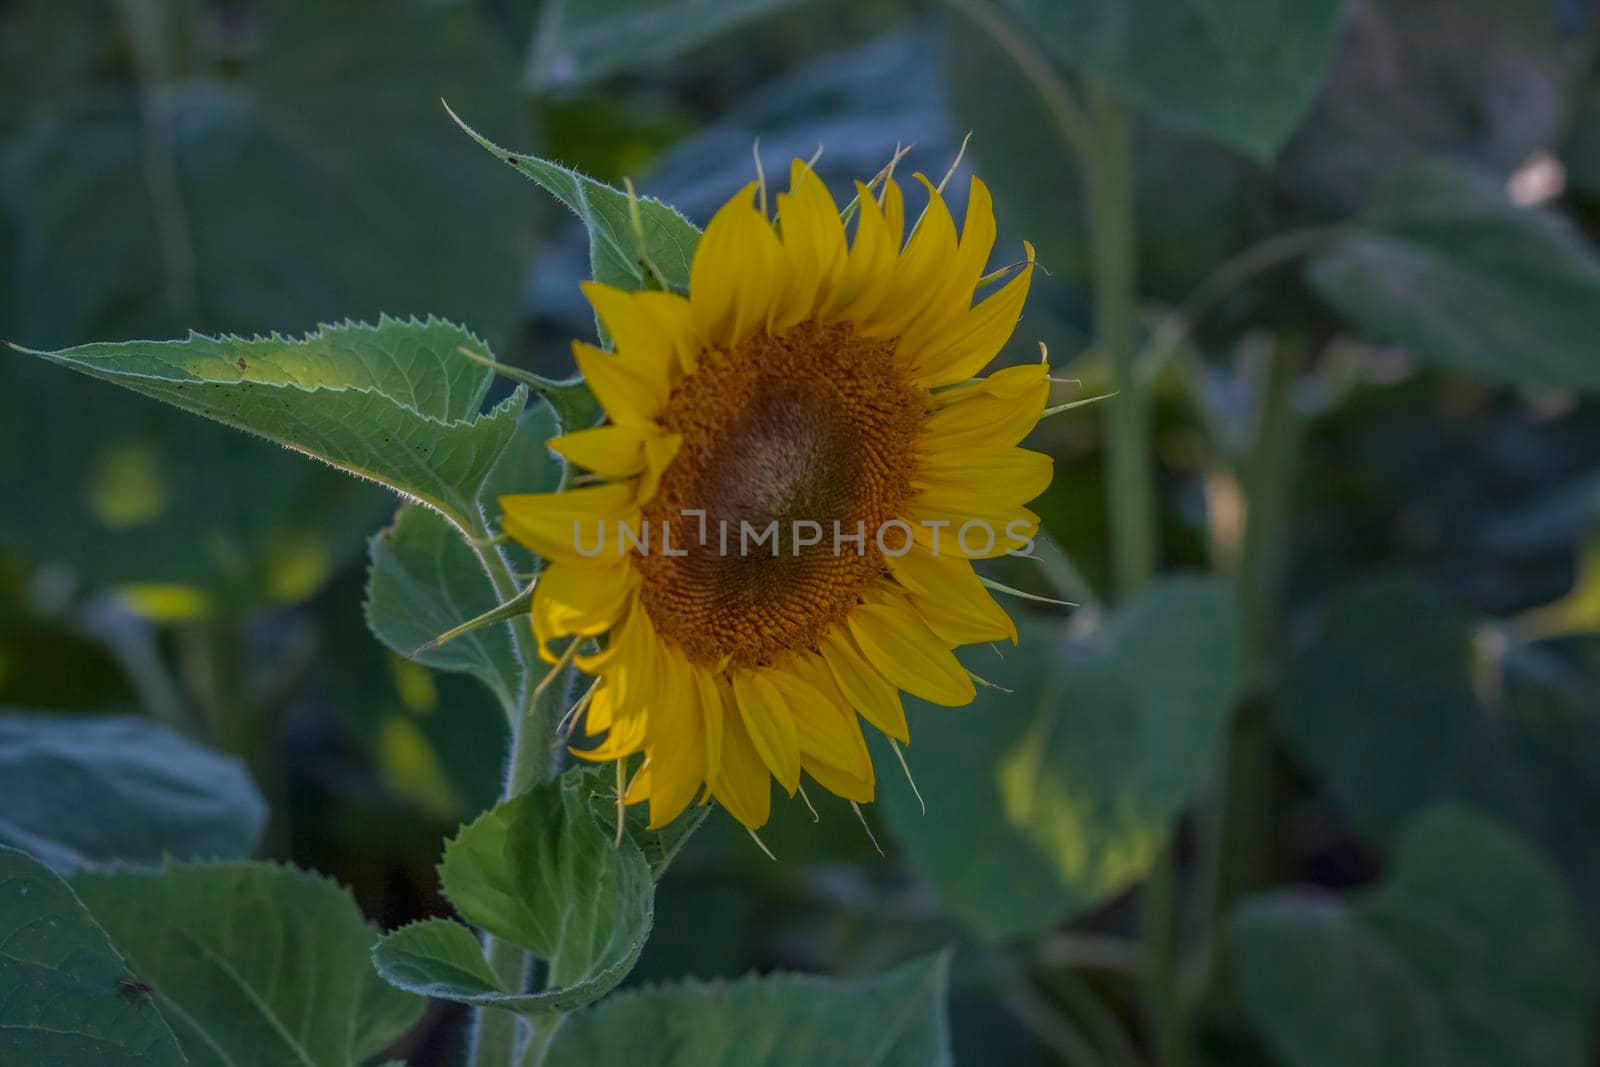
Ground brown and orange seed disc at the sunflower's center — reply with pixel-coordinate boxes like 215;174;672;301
638;323;923;665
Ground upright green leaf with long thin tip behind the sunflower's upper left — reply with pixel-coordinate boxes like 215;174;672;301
451;112;699;290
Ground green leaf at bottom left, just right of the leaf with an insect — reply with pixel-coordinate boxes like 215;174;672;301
72;864;422;1067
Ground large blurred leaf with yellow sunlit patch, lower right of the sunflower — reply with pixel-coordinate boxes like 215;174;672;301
878;577;1238;939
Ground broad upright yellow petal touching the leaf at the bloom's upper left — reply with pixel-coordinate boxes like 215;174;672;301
690;182;789;349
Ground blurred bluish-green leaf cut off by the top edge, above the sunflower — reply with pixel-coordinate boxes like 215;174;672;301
526;0;800;90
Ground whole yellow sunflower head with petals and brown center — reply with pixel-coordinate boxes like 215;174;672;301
501;160;1051;830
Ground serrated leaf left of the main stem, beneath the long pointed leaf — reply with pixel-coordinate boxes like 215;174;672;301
366;504;526;713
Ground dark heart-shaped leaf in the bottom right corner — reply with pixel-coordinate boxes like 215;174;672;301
1234;808;1592;1067
